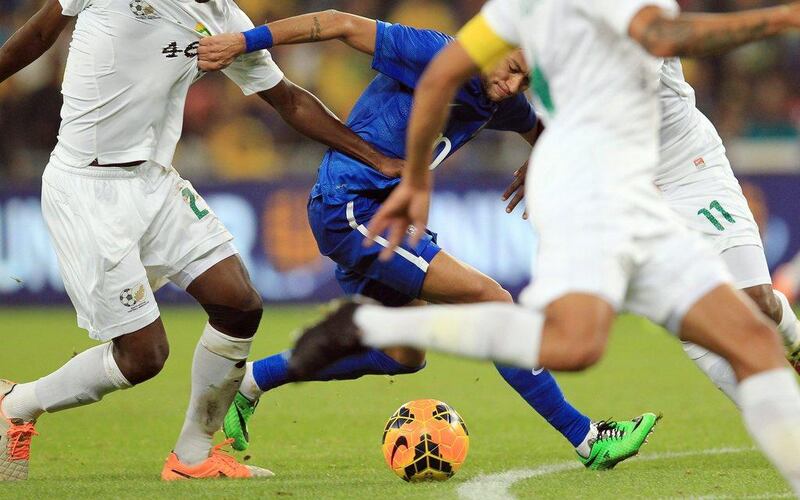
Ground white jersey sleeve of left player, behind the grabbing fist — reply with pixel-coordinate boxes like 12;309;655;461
223;6;283;95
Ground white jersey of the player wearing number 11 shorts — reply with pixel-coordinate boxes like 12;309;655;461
656;58;725;187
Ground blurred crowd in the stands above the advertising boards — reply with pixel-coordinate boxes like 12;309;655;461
0;0;800;184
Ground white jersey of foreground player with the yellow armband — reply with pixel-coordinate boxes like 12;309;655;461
483;0;679;232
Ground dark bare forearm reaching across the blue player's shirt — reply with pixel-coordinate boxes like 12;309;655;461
258;79;405;177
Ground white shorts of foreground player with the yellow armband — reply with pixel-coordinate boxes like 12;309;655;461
522;161;731;333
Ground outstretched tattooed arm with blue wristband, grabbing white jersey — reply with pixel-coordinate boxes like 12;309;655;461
198;10;378;71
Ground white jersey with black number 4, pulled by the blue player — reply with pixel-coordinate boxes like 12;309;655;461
53;0;283;167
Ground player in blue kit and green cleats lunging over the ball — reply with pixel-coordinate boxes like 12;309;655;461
198;11;657;469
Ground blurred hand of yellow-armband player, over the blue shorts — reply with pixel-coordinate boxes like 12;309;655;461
364;179;431;261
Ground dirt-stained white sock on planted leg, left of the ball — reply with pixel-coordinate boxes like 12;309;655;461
175;324;253;465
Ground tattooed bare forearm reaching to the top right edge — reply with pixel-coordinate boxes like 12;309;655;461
629;2;800;57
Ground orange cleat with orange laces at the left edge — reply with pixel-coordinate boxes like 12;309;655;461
0;380;36;481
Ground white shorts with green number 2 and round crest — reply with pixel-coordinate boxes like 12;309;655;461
42;159;237;341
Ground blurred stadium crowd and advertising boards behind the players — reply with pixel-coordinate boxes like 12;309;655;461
0;0;800;304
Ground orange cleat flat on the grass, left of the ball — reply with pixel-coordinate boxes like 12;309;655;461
161;439;275;481
